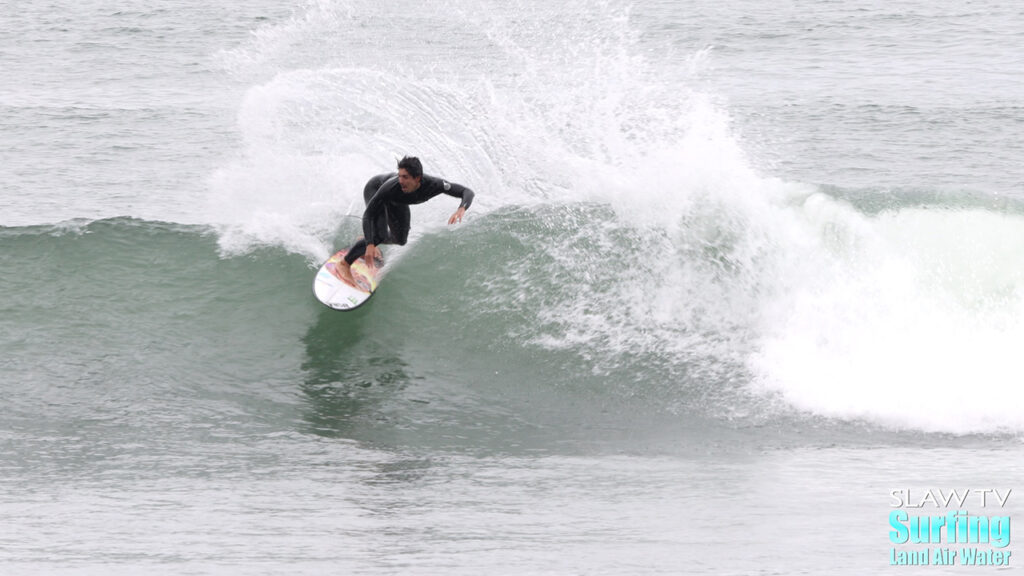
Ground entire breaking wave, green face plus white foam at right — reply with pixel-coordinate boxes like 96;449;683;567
8;199;1024;449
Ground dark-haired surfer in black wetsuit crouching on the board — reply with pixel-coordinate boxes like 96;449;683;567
337;156;473;286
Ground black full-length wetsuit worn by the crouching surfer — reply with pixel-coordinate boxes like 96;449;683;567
345;172;473;264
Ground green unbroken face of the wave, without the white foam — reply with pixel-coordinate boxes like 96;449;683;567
6;205;1015;474
